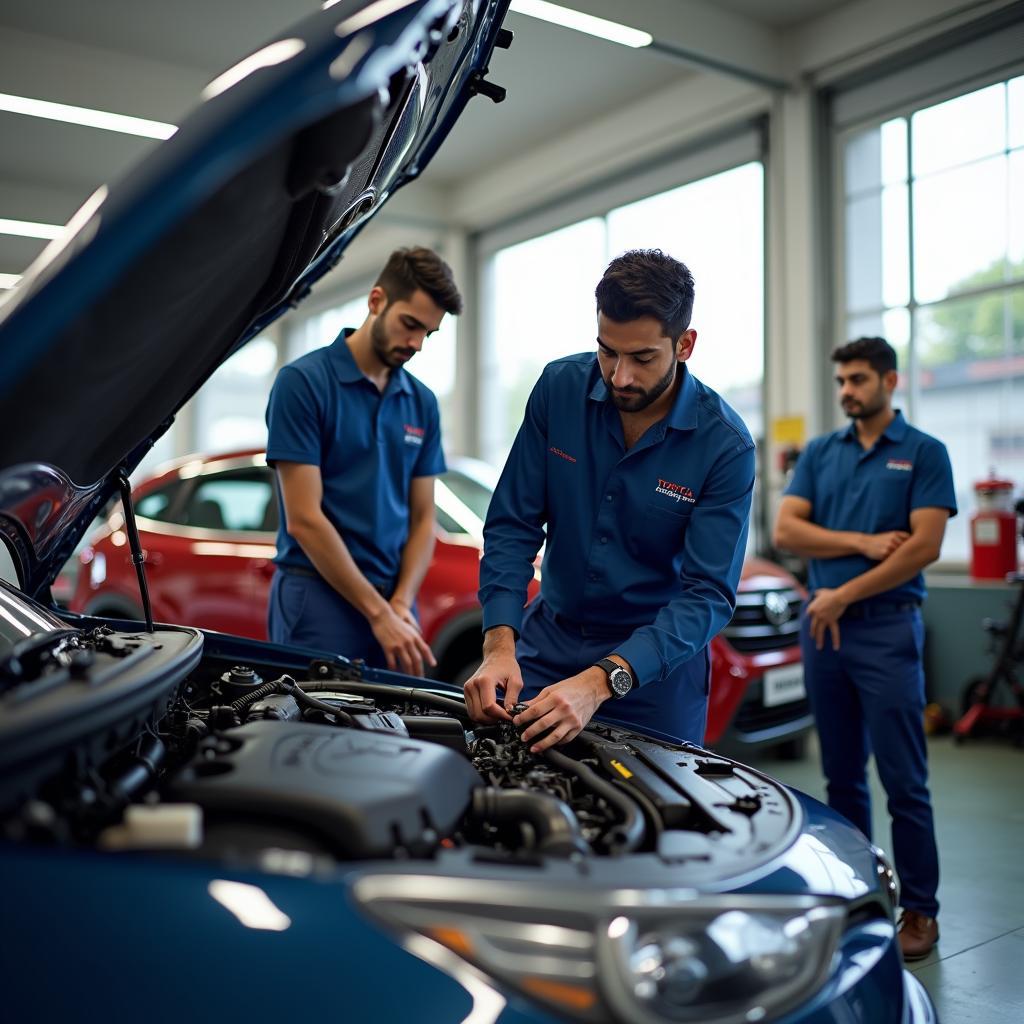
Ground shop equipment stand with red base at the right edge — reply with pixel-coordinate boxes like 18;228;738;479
953;572;1024;746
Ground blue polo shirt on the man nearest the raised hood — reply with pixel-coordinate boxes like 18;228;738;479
266;330;444;586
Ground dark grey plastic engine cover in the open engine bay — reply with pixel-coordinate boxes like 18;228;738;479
167;721;483;859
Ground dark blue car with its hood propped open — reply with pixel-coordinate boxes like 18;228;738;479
0;0;935;1024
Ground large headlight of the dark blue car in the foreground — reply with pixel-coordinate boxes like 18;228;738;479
354;874;846;1024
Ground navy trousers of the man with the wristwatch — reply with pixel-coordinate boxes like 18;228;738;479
516;597;711;743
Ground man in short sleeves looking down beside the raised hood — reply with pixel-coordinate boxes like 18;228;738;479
266;248;462;676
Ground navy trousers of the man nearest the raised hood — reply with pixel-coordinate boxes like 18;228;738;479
267;569;387;669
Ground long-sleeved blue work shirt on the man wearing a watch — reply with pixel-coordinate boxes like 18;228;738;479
480;352;754;685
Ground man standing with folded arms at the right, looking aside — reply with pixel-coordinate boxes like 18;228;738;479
775;338;956;959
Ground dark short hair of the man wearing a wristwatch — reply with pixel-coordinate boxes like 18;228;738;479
595;249;693;341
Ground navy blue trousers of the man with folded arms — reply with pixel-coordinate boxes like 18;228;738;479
800;608;939;918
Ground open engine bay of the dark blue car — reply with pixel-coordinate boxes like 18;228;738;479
0;626;799;878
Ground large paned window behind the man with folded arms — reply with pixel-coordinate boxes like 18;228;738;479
839;75;1024;561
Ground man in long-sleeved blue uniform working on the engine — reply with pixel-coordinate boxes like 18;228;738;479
465;250;754;751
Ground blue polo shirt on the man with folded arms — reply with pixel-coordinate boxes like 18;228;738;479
785;410;956;601
